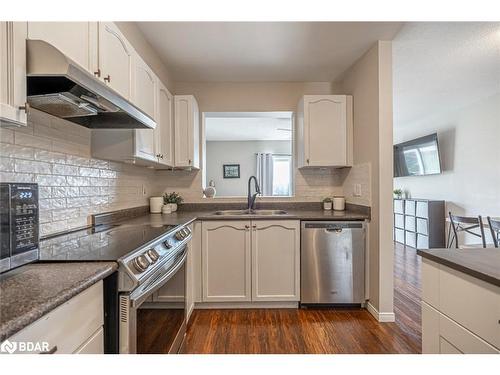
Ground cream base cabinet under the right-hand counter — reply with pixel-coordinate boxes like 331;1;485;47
422;258;500;354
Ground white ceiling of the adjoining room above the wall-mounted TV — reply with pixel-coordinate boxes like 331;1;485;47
392;22;500;128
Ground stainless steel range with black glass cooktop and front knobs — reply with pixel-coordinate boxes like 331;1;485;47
40;224;192;353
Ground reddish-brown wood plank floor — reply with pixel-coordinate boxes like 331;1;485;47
184;244;421;354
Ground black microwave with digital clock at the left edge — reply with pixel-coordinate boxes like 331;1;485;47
0;182;39;273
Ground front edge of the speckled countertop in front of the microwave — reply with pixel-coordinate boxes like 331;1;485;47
0;262;118;342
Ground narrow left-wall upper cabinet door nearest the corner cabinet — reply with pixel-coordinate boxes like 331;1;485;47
155;82;174;167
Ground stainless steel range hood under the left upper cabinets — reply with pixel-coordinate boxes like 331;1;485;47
26;40;156;129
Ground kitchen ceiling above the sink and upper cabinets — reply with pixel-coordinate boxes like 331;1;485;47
138;22;402;82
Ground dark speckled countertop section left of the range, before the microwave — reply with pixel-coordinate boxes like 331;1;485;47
0;262;118;342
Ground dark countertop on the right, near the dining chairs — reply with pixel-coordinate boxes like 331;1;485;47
417;248;500;287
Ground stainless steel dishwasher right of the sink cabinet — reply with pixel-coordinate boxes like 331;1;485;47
300;221;365;305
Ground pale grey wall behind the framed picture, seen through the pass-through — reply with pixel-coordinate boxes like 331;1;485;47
207;141;292;197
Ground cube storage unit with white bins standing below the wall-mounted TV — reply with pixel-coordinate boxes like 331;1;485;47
394;199;446;249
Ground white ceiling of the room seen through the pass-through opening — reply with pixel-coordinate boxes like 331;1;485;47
205;113;292;141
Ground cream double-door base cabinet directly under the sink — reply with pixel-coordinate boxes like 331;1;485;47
202;220;300;302
